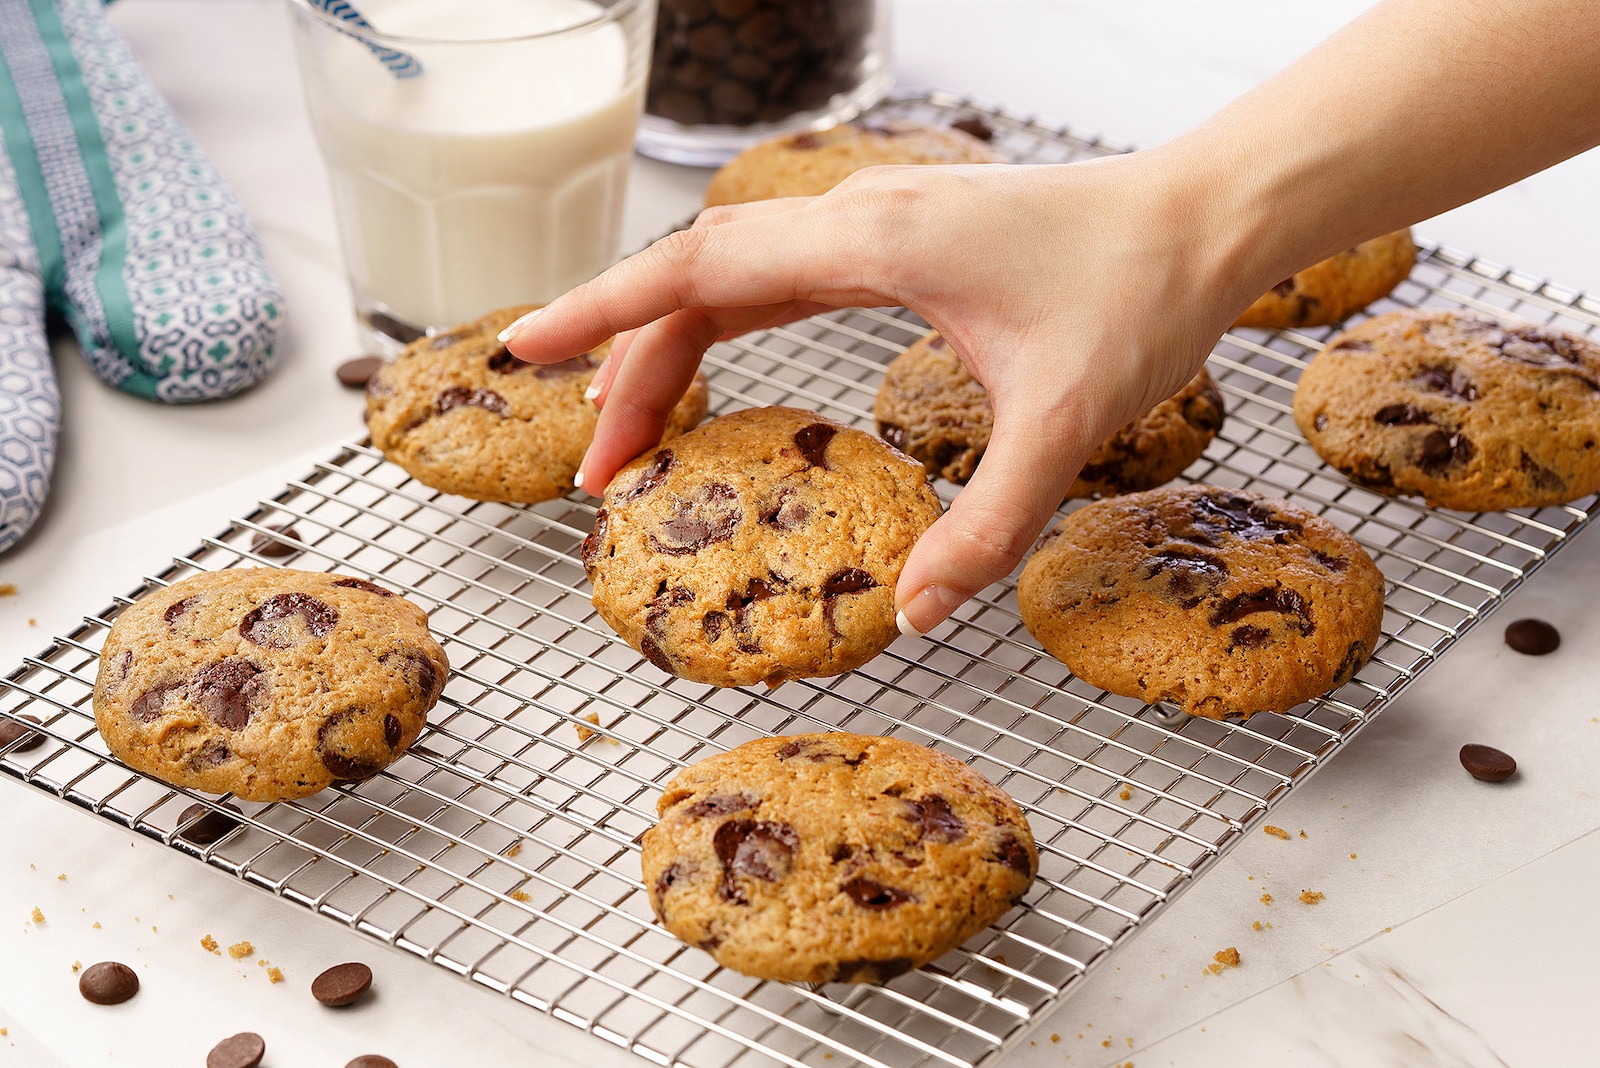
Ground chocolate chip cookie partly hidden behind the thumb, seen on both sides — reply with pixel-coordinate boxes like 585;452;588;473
872;331;1226;499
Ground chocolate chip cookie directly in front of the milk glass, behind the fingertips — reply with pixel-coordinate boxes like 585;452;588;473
366;305;707;504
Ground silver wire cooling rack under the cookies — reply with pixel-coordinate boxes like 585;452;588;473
0;94;1600;1068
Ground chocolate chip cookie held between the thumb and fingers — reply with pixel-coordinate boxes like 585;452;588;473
582;408;939;686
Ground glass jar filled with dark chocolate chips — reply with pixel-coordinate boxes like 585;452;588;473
637;0;894;166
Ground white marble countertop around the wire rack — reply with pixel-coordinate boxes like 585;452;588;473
0;0;1600;1068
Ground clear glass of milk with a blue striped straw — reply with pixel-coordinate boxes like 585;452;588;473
290;0;656;353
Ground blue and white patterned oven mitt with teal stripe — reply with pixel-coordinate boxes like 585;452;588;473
0;0;283;552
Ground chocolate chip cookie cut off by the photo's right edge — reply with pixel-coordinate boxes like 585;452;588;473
1294;309;1600;512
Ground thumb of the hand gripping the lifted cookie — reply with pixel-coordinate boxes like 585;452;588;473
894;404;1098;635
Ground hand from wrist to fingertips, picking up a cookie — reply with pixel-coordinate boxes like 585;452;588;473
507;152;1270;633
